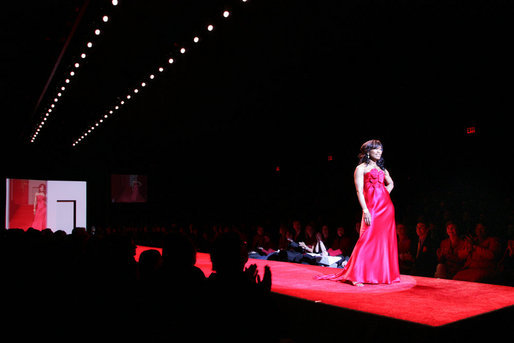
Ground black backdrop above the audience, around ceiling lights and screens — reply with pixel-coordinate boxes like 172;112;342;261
0;0;514;231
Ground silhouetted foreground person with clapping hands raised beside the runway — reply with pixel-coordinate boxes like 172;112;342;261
206;232;278;342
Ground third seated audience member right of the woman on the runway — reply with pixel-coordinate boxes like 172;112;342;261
434;222;468;279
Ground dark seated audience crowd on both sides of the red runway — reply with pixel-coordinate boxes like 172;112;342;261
0;192;514;341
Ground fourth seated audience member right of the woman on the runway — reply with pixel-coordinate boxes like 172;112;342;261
453;223;501;282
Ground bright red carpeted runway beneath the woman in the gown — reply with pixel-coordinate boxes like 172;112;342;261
196;253;514;326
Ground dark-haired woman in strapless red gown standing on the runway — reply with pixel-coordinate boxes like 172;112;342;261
317;140;400;286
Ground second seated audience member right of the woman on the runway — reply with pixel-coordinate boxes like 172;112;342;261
413;222;436;276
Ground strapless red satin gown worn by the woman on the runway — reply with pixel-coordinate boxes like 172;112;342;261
316;169;400;284
